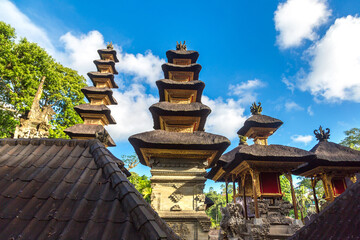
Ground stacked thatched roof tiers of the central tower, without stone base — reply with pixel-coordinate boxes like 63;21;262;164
129;41;230;166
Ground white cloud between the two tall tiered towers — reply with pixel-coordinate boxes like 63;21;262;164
107;84;158;141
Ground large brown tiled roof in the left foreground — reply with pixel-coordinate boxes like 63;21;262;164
0;139;178;240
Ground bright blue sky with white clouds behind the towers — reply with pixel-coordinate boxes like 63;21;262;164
0;0;360;191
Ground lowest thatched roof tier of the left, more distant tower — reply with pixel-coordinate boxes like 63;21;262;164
64;124;116;147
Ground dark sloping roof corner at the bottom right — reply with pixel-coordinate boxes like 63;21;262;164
289;182;360;240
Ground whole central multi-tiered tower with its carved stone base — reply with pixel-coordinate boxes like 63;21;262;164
129;42;230;239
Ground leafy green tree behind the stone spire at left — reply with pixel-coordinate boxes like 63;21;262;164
0;22;85;138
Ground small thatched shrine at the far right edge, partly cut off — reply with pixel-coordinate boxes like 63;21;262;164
293;126;360;212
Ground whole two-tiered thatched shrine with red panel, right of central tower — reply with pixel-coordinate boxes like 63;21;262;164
206;103;315;239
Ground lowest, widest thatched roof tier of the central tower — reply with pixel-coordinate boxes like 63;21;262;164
129;130;230;167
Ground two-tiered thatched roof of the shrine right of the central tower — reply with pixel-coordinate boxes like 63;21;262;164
206;103;315;181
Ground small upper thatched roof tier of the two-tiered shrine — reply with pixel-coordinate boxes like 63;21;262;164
237;115;283;136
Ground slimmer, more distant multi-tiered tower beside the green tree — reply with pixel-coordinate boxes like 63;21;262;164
64;43;119;147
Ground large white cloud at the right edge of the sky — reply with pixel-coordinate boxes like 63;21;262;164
298;16;360;102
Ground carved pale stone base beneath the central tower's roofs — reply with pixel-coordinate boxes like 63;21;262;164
150;159;211;240
